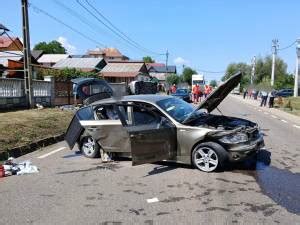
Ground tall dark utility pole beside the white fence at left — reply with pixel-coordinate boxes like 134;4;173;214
21;0;33;108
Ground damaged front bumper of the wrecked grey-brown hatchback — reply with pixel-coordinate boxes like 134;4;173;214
227;135;265;162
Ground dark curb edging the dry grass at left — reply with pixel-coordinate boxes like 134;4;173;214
0;134;65;161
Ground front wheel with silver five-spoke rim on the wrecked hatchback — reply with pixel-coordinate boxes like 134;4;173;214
192;142;228;172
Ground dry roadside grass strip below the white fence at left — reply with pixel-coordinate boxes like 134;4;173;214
0;108;73;152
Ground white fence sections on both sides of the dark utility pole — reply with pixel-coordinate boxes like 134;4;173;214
0;78;51;98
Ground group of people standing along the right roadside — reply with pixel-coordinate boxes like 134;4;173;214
243;89;275;108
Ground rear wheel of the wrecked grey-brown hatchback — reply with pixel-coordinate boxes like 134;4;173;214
80;136;100;158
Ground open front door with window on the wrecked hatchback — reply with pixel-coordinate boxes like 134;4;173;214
119;103;177;166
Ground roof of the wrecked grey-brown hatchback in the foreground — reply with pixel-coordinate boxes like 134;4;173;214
92;94;172;105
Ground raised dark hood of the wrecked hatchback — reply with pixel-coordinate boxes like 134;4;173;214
197;72;242;113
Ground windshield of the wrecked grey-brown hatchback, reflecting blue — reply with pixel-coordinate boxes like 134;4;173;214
157;98;195;123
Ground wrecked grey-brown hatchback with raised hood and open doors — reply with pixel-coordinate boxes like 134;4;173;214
65;73;264;172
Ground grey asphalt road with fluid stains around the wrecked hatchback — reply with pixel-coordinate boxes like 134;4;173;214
0;97;300;224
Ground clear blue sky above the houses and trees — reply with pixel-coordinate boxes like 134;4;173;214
0;0;300;80
